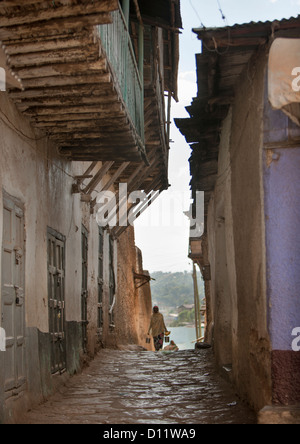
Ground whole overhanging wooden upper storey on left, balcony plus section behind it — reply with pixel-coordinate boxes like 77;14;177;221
0;0;182;222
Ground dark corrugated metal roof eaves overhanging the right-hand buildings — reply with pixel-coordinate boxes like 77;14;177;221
175;16;300;219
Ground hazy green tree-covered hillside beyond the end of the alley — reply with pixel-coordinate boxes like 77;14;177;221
151;271;204;307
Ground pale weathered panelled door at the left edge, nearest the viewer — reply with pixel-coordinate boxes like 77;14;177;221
0;194;26;398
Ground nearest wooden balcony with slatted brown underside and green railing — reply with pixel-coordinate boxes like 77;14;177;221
0;0;146;162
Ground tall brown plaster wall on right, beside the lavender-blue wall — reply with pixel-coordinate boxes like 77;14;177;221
231;49;271;409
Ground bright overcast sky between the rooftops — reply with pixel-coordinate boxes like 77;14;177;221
135;0;300;272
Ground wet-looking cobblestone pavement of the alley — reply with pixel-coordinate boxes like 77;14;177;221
22;350;256;424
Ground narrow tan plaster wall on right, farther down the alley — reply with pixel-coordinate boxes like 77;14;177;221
207;107;237;366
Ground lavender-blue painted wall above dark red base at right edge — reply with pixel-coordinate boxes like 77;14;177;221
264;146;300;350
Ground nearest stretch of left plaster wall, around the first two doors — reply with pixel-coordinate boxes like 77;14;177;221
0;93;90;424
